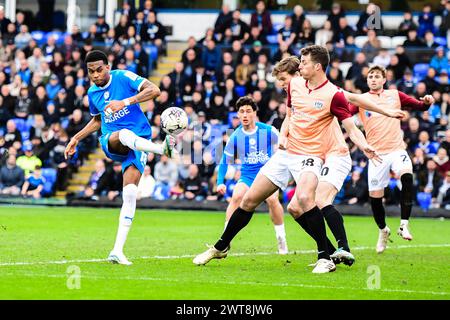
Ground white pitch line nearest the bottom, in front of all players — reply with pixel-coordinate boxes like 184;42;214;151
2;273;450;296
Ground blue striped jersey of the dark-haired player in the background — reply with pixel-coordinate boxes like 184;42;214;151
218;122;278;184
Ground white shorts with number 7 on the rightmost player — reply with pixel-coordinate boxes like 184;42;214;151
368;150;412;191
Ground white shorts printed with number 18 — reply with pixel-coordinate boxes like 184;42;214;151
260;150;323;190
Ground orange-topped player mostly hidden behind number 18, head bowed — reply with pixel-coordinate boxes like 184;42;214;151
272;56;405;265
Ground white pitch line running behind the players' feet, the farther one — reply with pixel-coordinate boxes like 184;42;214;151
0;243;450;267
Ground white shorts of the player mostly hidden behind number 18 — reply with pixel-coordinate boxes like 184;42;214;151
319;154;352;191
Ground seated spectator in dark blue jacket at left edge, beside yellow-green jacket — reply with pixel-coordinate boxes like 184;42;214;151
0;154;25;195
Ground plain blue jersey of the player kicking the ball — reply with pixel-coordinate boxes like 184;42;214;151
88;70;151;137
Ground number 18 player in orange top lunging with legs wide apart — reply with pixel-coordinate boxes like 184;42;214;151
193;46;388;273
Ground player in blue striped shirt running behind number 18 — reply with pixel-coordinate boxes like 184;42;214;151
217;97;288;254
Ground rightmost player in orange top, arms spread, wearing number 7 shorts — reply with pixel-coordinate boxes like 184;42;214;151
350;65;434;253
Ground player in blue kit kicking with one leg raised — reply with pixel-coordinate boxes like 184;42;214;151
65;50;175;265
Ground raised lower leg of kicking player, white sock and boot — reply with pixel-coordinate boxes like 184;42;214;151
118;129;175;158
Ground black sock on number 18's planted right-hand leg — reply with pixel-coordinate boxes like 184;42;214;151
303;206;330;260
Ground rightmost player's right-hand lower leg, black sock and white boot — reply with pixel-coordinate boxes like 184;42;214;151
397;172;414;240
